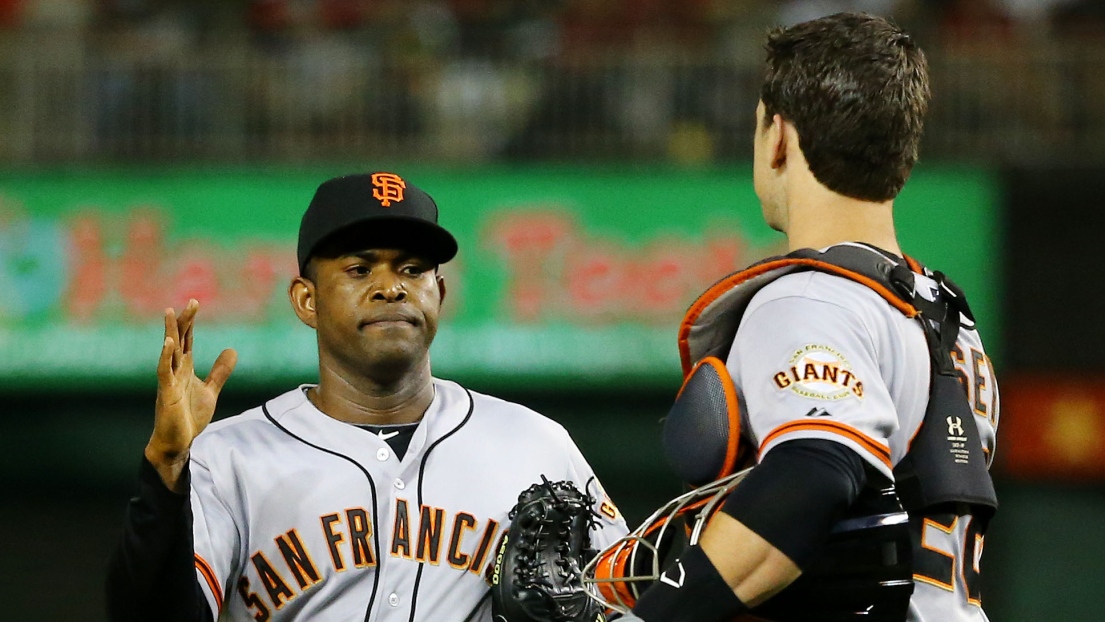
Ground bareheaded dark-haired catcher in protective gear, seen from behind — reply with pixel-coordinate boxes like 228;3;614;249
625;14;1000;622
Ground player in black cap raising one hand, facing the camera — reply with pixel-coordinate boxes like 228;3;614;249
107;172;625;622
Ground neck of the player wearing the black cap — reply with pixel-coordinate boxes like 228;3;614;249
307;359;433;425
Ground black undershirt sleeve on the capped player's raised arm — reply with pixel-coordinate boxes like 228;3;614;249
105;457;212;622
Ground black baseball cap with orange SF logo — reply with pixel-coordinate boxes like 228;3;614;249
297;171;456;274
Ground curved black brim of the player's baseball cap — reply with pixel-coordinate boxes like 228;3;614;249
299;215;457;271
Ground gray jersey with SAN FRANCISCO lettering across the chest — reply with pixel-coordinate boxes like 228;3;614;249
185;379;627;622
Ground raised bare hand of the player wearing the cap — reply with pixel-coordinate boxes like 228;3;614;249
146;299;238;494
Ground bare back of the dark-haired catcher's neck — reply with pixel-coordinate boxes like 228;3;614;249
786;185;902;255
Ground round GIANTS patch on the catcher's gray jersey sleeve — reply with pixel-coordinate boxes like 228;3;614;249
771;344;863;401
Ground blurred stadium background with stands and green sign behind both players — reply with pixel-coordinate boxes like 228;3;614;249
0;0;1105;622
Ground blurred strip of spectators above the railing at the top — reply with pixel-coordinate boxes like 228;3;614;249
0;0;1105;52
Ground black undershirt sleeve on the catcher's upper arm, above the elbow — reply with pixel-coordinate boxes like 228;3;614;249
722;439;866;569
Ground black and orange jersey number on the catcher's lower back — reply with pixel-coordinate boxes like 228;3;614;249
913;514;983;605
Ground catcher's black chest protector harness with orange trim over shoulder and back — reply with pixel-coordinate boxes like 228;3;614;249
678;244;998;519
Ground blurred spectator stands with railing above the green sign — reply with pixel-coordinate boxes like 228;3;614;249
0;0;1105;161
